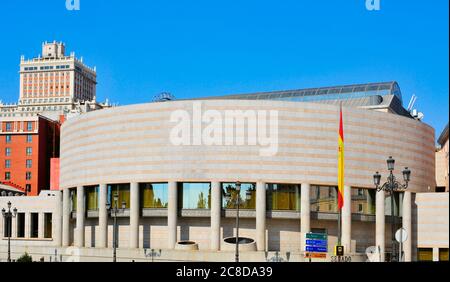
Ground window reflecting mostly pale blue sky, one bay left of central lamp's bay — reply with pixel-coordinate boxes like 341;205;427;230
178;182;211;209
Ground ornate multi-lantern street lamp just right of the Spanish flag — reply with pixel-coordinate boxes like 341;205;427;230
373;157;411;261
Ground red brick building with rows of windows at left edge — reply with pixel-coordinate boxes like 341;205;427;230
0;115;60;196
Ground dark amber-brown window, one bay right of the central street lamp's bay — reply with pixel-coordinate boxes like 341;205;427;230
266;184;300;211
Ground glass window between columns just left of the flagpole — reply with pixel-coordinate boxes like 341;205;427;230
310;185;337;213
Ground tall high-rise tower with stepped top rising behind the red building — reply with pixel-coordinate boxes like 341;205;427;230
0;41;108;120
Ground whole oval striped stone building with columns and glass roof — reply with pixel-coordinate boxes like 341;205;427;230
0;82;442;261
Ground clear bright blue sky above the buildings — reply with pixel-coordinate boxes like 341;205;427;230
0;0;449;138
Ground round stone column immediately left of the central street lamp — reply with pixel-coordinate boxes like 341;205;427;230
211;182;222;251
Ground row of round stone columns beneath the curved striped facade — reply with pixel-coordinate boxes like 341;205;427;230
62;182;411;261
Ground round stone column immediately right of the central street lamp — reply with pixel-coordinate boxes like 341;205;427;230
256;182;266;251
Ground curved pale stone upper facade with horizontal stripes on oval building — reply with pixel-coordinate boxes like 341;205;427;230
60;100;435;191
